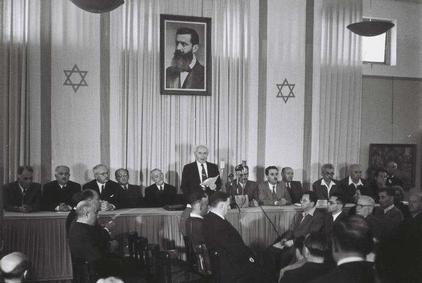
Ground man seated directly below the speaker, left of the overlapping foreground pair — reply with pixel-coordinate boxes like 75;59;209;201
185;191;208;246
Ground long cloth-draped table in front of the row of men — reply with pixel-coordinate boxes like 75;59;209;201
3;206;298;281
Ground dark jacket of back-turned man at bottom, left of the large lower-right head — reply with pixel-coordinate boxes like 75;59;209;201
279;262;334;283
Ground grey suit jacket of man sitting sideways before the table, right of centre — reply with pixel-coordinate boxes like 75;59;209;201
283;209;325;239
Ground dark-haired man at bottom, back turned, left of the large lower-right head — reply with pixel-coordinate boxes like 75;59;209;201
279;232;330;283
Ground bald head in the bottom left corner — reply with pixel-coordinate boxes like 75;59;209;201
0;252;30;282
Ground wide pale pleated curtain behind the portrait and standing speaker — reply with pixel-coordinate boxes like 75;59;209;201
110;0;259;189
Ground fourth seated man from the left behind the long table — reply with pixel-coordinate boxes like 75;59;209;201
114;168;143;208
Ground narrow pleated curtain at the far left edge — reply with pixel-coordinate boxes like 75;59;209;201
0;0;29;189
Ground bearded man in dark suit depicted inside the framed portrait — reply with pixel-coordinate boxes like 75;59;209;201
166;28;205;89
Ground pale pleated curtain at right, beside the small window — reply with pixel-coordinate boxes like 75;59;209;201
311;0;362;180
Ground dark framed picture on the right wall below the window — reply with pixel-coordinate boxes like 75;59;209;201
368;143;417;189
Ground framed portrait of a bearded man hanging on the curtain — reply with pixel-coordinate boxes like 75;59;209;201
160;14;212;95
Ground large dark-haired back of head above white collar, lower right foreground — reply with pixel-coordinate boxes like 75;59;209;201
332;215;373;261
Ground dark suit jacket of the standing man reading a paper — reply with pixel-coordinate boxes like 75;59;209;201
180;161;221;198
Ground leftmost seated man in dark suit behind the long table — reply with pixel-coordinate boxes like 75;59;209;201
3;166;41;213
